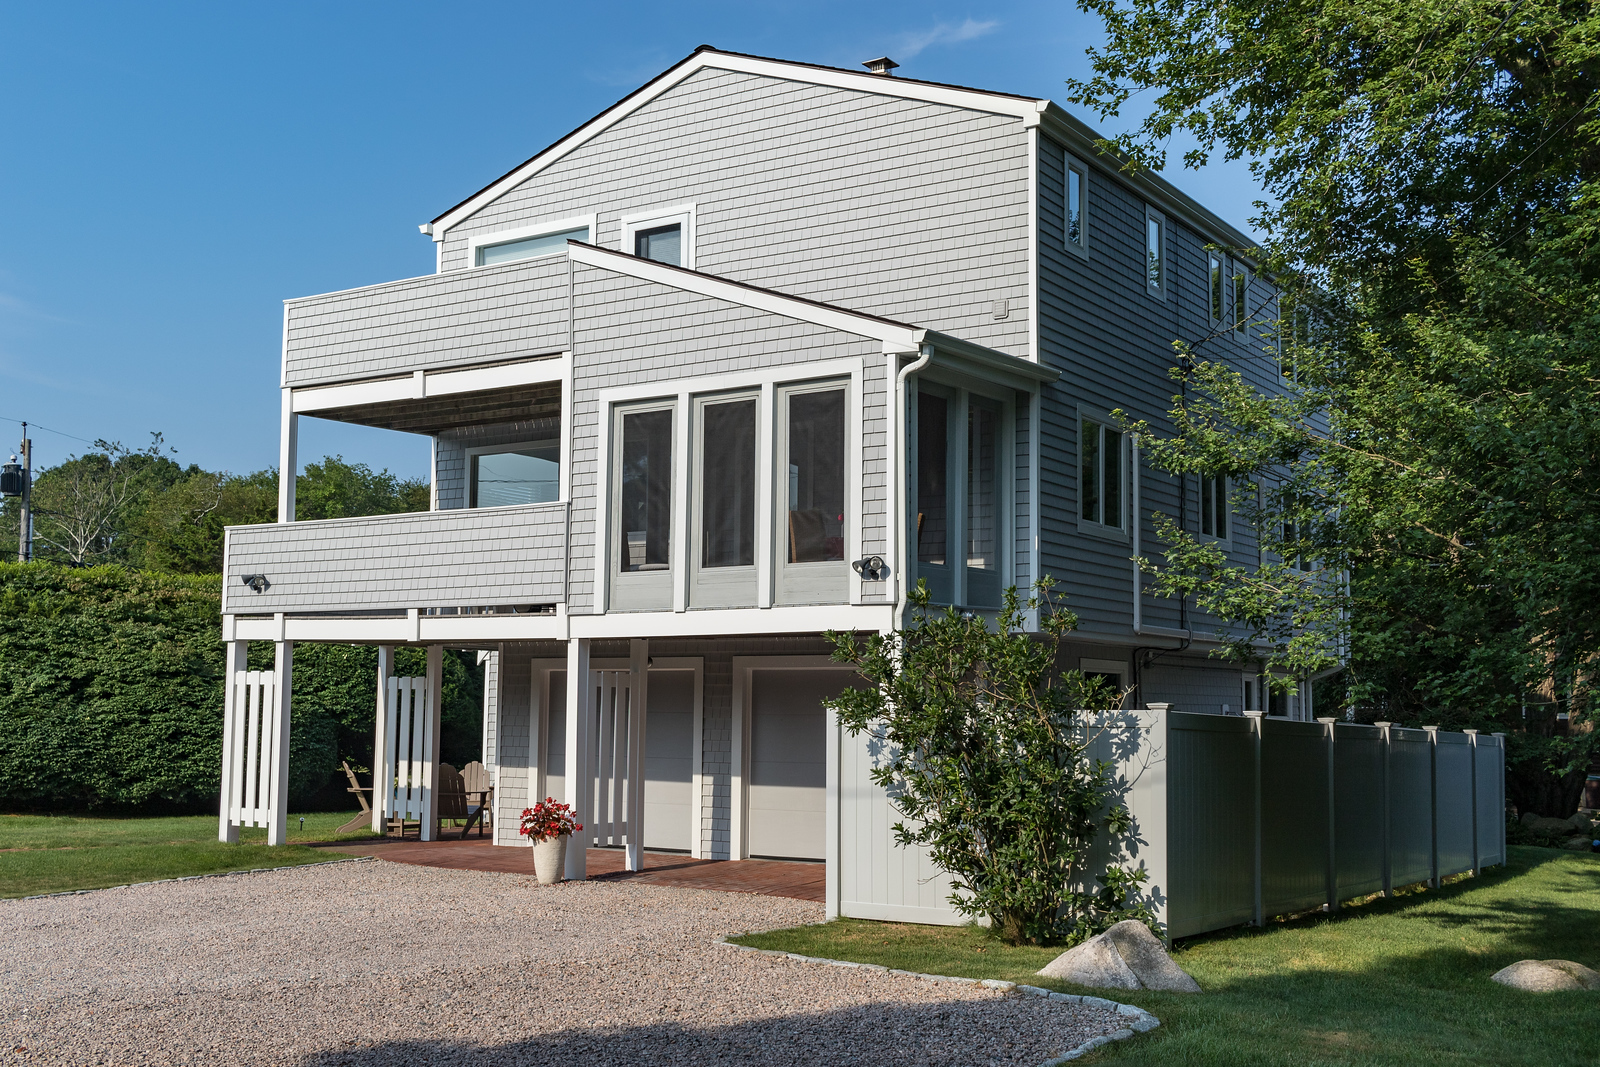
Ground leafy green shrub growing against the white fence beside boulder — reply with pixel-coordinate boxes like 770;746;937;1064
829;579;1154;944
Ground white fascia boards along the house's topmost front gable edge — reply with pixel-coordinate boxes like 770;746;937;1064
427;51;1050;242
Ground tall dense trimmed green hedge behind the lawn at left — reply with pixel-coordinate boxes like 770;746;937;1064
0;563;482;811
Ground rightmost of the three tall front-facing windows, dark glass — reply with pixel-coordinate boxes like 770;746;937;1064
787;389;845;563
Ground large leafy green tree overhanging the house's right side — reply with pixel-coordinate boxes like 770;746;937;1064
1070;0;1600;814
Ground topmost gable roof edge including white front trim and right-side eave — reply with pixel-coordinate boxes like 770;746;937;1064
419;45;1256;260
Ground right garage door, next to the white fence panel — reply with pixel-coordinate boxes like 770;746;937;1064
746;670;856;859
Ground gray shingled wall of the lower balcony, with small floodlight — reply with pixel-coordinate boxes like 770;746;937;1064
222;504;566;613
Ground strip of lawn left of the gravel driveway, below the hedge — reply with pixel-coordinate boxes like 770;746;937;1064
0;811;371;897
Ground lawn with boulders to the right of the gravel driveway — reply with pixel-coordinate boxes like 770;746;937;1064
738;848;1600;1067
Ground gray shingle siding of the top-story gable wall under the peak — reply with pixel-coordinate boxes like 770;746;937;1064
442;70;1029;355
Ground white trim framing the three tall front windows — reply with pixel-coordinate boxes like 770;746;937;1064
594;358;866;614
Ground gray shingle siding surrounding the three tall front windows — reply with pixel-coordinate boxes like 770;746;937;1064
568;266;886;613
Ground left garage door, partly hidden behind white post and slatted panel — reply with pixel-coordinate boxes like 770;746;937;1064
544;670;694;851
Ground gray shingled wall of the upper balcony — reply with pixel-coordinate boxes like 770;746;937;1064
283;256;566;386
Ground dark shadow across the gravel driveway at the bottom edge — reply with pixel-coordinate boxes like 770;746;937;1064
299;1004;1122;1067
